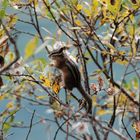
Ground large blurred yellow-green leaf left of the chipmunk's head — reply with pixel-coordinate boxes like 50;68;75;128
24;36;38;59
